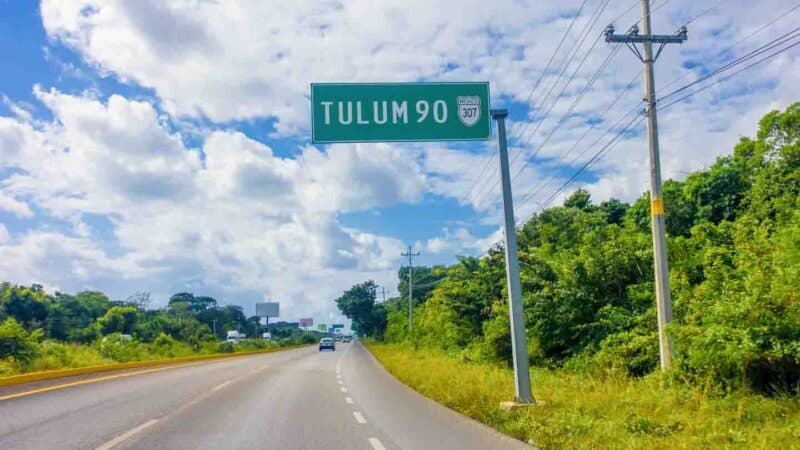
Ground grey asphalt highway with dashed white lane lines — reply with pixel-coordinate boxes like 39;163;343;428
0;343;529;450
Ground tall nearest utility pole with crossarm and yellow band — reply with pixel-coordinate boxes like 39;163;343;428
605;0;687;370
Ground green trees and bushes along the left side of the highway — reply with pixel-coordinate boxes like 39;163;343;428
0;288;318;377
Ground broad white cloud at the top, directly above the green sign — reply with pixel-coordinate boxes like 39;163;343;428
41;0;624;131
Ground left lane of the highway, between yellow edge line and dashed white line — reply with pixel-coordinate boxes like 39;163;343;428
0;348;315;449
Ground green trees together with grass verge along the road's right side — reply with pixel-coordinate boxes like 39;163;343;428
336;103;800;448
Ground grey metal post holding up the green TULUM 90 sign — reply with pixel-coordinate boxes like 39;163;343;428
492;109;533;403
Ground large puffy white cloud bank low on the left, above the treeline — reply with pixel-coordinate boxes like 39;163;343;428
0;89;425;320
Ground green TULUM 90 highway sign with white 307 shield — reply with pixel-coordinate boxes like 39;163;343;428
311;82;492;143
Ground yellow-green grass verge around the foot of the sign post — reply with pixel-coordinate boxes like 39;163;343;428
367;343;800;449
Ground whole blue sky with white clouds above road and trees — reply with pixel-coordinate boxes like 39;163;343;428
0;0;800;322
